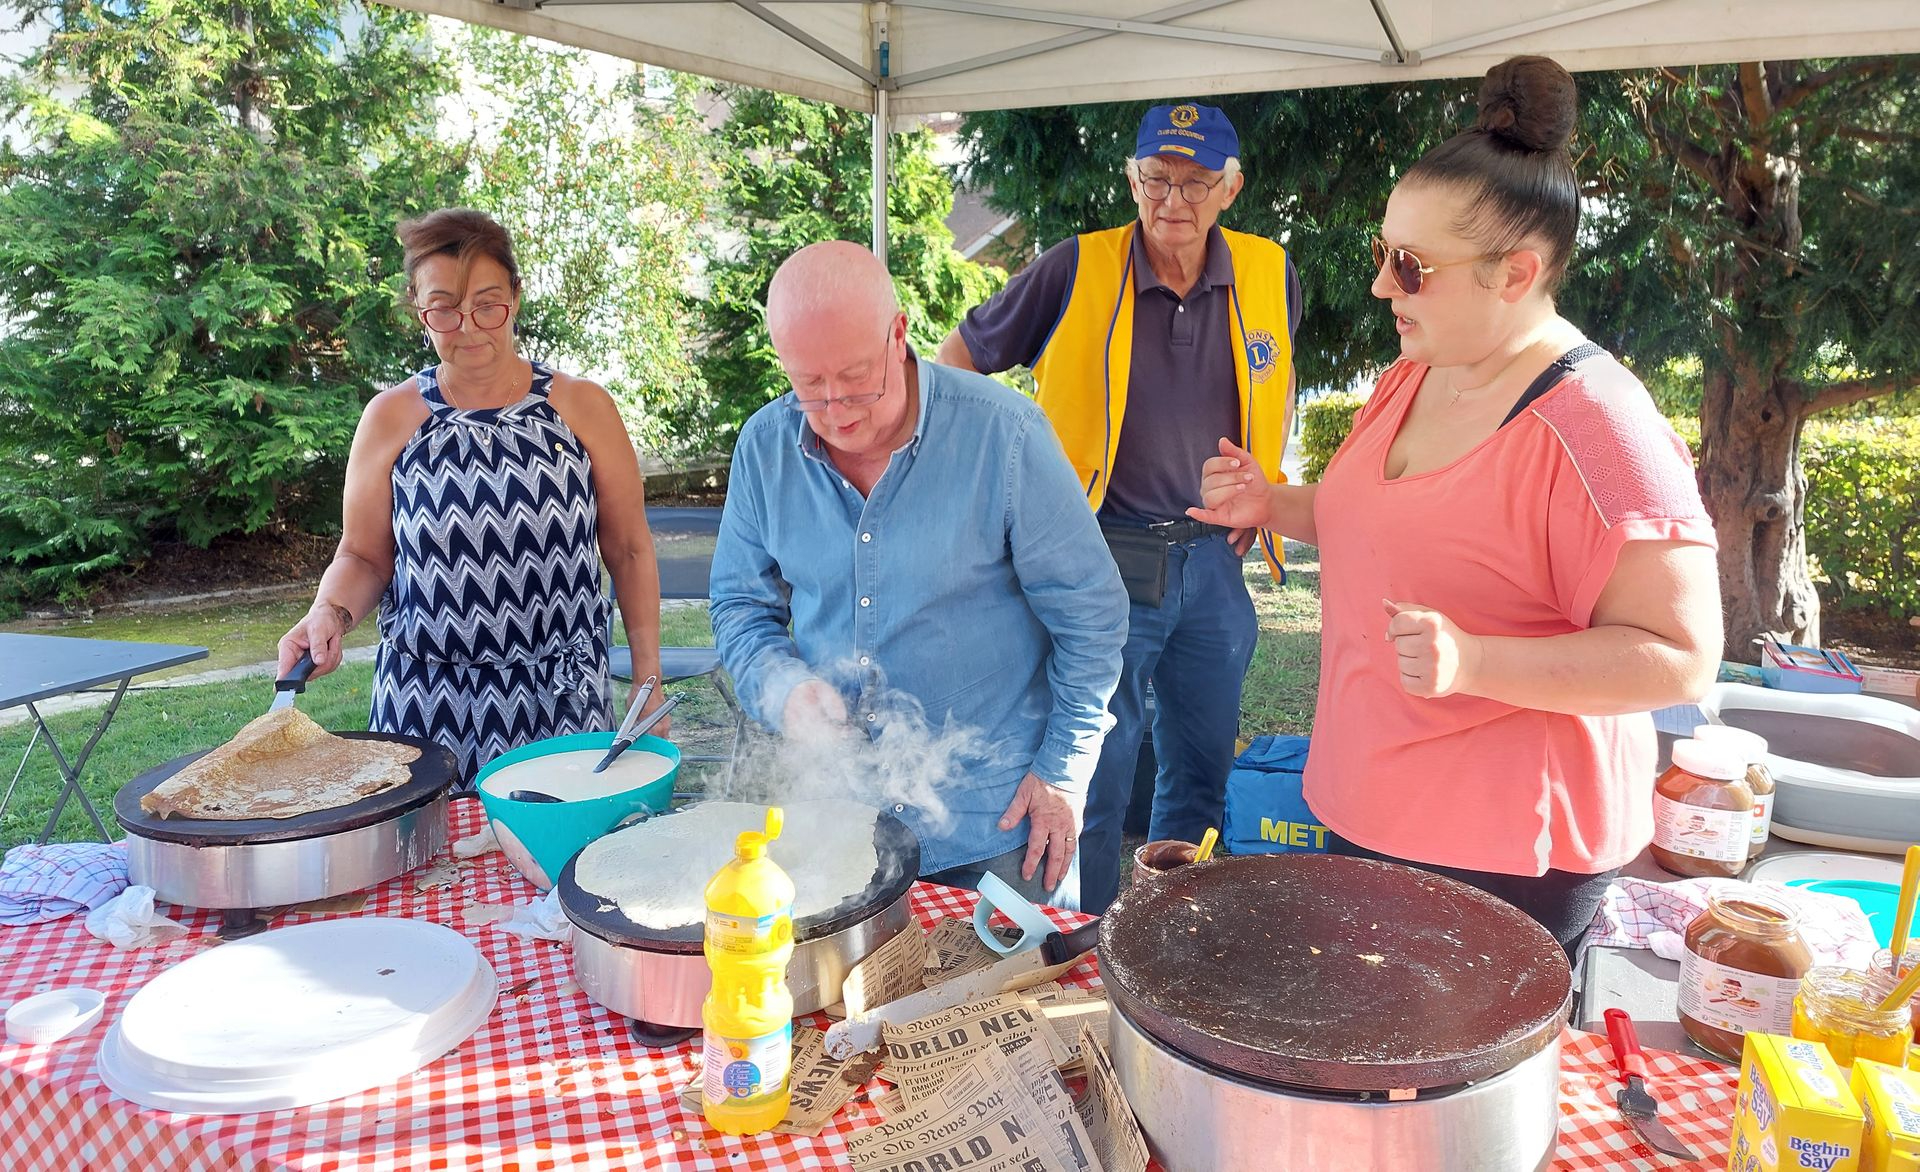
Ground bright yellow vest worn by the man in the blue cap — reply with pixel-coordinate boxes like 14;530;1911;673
1033;221;1294;578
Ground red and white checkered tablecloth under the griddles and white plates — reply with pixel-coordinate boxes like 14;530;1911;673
0;801;1734;1172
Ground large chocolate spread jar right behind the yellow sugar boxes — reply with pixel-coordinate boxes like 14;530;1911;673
1680;883;1812;1062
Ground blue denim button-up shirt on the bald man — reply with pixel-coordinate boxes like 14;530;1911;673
710;359;1127;874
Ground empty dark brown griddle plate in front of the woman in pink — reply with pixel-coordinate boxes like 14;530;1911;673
1100;855;1572;1091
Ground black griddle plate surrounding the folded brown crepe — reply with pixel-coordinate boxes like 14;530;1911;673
113;732;457;847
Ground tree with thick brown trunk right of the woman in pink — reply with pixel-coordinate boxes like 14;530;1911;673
1574;58;1920;651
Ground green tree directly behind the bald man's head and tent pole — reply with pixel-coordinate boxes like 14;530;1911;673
701;86;1002;446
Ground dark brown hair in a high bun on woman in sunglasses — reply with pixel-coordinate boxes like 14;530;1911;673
1404;58;1580;294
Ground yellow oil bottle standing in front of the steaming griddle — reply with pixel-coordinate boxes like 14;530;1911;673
701;807;793;1135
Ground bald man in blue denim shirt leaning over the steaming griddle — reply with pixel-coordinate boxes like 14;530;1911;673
710;242;1127;907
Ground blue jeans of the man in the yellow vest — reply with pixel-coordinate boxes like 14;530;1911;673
1081;534;1258;915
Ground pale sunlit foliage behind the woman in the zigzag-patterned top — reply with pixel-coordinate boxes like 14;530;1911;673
451;27;710;450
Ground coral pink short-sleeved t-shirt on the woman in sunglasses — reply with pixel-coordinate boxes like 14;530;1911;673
1306;355;1715;874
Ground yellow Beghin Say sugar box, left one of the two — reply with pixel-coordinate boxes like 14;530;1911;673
1726;1034;1866;1172
